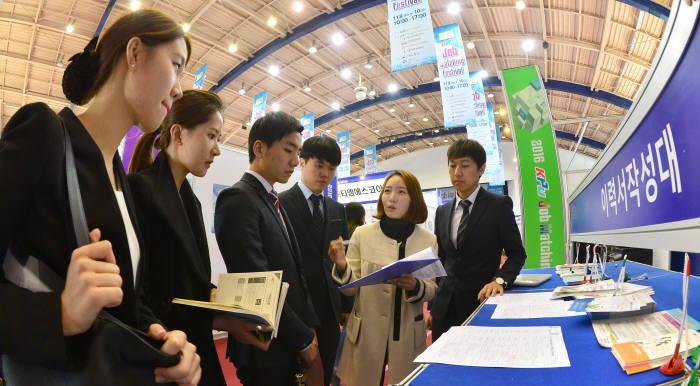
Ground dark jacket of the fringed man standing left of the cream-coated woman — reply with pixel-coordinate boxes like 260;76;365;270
279;184;352;323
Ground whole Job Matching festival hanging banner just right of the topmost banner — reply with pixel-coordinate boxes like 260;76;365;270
435;24;474;128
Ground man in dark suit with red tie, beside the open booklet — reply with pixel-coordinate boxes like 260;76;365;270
214;112;322;385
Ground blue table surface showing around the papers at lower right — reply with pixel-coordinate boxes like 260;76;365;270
401;261;700;386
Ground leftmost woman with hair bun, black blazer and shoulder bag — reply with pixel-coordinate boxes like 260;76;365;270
0;10;201;385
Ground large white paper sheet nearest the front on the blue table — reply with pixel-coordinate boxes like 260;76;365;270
414;326;571;368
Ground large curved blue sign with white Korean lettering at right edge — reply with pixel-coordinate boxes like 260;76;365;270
571;21;700;233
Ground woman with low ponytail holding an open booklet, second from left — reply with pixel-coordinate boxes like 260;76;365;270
128;90;270;385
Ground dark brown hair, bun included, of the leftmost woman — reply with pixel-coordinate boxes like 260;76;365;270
62;9;192;106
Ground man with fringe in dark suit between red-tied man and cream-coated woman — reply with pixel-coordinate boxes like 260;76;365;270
280;137;352;385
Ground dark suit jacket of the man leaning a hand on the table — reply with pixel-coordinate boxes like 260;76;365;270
431;188;526;318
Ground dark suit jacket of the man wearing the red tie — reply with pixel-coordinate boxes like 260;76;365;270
214;173;319;367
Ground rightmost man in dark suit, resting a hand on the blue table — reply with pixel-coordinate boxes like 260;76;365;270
430;139;526;341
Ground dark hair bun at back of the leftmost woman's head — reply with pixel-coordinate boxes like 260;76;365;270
62;37;99;105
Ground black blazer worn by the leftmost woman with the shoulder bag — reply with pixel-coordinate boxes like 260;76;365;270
0;103;156;368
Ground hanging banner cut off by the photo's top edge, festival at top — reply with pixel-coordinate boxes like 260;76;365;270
387;0;435;72
